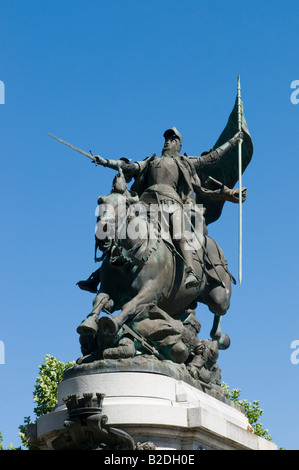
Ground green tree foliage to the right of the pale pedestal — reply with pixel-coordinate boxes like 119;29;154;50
222;384;272;441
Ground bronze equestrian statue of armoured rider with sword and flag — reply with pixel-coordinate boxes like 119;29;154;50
48;96;253;386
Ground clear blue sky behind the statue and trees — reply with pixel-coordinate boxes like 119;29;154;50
0;0;299;449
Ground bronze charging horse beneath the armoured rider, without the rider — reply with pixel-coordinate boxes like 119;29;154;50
78;177;231;349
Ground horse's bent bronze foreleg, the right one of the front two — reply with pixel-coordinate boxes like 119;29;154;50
98;280;158;334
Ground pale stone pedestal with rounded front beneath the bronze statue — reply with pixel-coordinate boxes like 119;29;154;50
31;360;276;450
